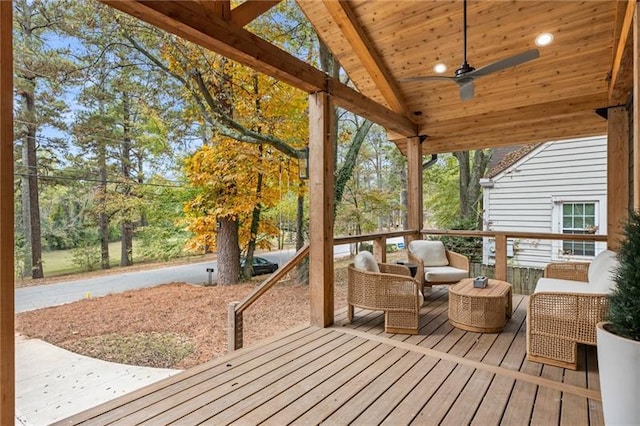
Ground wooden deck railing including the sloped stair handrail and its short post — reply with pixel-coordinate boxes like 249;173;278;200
227;229;607;352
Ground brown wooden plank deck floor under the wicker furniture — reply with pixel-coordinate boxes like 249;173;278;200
53;288;604;425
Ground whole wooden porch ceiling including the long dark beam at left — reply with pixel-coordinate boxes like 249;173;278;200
101;0;635;154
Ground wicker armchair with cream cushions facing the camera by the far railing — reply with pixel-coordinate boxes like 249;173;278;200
407;240;469;289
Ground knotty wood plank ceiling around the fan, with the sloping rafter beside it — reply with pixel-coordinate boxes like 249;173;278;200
298;0;631;153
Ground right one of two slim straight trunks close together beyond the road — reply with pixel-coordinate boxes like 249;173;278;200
120;92;133;266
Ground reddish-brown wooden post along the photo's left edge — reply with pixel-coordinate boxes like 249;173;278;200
0;1;16;425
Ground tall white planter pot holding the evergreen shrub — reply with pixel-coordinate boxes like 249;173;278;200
596;322;640;425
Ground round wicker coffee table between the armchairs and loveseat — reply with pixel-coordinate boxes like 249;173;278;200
449;278;512;333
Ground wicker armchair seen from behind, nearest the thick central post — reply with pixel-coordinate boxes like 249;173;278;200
347;251;424;334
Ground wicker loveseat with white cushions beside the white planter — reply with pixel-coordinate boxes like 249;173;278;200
527;250;617;370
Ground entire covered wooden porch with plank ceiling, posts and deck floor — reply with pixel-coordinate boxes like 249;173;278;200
0;0;640;424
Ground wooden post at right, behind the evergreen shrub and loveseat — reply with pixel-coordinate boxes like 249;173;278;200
607;107;629;251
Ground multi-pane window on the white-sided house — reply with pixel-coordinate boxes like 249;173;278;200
562;202;598;256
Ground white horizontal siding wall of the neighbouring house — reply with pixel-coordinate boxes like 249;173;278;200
481;136;607;268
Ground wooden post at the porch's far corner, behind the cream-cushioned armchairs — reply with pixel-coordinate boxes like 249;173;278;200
407;137;424;241
